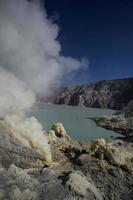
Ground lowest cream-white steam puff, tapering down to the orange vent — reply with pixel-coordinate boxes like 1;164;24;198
0;116;52;163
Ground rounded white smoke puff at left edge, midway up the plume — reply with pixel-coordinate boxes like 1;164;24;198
0;67;35;118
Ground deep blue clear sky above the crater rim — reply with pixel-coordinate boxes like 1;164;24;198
45;0;133;85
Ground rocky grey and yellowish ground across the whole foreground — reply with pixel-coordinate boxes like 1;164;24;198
0;123;133;200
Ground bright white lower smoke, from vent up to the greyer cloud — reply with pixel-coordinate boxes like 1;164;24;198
0;68;52;161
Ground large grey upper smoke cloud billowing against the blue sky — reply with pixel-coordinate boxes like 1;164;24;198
0;0;86;94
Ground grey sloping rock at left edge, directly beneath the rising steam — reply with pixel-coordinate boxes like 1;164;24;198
0;128;45;168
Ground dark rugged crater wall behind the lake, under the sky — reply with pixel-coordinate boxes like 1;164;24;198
41;78;133;110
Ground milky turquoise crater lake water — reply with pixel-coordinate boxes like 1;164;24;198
30;105;119;140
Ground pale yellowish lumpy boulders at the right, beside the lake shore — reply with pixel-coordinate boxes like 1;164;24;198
90;139;133;171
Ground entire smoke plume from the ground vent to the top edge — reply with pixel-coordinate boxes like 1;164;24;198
0;0;87;162
